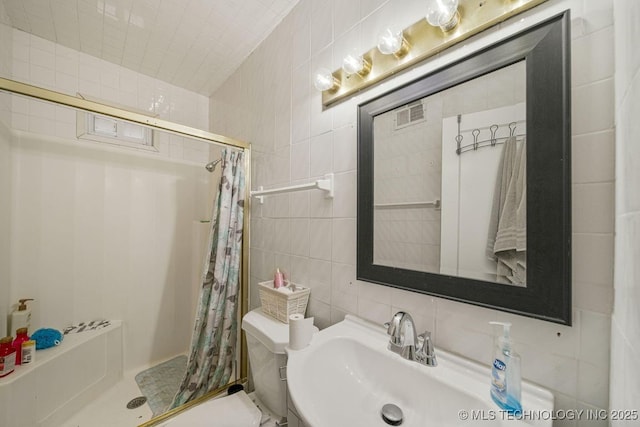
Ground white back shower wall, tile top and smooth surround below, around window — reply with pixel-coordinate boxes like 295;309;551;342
2;26;213;369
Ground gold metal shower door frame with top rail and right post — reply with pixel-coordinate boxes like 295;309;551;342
0;77;251;427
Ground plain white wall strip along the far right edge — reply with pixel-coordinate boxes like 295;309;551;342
610;0;640;420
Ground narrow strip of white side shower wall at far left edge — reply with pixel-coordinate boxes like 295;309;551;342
0;19;11;342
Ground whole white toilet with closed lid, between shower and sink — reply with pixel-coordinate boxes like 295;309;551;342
163;308;318;427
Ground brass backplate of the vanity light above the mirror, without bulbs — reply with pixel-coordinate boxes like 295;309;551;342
322;0;547;108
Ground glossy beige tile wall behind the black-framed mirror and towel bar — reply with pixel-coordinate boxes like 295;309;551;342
210;0;615;426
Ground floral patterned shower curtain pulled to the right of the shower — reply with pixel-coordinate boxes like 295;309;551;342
168;149;245;409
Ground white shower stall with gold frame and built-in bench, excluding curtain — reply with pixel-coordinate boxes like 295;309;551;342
0;78;251;426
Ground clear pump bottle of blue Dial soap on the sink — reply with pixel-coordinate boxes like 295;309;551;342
489;322;522;416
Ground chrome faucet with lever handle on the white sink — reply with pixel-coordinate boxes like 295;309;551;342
384;311;438;366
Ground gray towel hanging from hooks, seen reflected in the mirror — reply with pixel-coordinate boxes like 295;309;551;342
487;137;527;286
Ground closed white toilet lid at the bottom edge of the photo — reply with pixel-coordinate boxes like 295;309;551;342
162;391;262;427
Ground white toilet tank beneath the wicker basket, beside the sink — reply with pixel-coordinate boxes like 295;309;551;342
242;308;289;417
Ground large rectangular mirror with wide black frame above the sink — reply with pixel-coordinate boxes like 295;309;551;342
357;11;571;325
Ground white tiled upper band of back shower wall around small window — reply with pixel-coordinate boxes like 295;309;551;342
11;30;209;164
